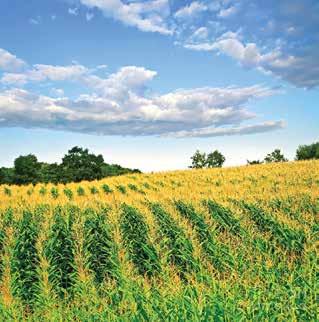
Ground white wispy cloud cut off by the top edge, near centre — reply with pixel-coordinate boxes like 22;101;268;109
80;0;173;35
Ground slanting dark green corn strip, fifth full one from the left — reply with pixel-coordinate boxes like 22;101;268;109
150;203;198;279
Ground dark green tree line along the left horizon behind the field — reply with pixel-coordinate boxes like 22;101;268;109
0;146;141;185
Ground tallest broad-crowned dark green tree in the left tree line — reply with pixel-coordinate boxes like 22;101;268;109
61;146;104;182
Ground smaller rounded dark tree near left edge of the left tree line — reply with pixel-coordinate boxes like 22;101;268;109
13;154;41;184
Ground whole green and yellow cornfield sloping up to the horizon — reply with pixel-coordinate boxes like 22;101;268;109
0;161;319;321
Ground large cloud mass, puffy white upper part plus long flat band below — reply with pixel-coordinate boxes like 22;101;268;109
0;48;279;137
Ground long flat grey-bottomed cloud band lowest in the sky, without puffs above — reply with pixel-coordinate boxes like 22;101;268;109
0;87;278;137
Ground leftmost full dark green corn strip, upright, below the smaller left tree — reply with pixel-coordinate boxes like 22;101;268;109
11;211;39;306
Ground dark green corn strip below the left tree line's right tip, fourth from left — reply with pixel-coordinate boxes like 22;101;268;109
120;204;161;276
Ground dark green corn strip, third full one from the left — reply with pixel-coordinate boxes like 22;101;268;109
83;209;119;285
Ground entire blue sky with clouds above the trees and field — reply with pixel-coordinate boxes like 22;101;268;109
0;0;319;171
